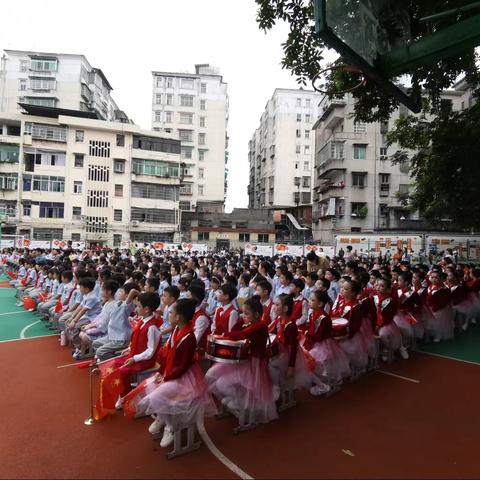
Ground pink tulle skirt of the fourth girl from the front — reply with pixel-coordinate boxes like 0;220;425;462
308;338;350;383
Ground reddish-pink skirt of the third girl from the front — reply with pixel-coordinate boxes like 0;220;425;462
268;345;313;389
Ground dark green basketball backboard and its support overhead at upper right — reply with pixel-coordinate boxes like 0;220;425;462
315;0;480;113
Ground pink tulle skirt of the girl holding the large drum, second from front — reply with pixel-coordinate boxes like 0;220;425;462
205;357;278;423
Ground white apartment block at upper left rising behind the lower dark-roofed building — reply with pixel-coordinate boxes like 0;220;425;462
0;50;128;122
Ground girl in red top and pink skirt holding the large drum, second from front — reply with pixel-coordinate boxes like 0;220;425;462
205;296;278;423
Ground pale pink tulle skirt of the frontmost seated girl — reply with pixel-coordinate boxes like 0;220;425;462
137;363;217;430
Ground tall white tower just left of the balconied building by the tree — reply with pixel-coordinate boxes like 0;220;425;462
248;88;322;208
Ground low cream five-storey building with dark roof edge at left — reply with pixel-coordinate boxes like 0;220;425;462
0;105;181;246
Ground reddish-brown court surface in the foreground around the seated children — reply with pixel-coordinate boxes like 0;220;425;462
0;338;480;479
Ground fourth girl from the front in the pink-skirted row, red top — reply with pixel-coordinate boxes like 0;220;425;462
303;290;350;394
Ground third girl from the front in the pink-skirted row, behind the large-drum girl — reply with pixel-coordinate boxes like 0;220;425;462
268;293;314;399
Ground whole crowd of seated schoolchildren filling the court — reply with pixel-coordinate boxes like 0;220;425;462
0;244;480;446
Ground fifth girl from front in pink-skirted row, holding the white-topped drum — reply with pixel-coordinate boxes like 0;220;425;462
330;278;368;376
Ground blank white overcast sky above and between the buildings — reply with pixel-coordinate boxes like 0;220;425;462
0;0;304;211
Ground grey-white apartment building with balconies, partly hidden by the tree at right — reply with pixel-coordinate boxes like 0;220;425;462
312;87;465;244
